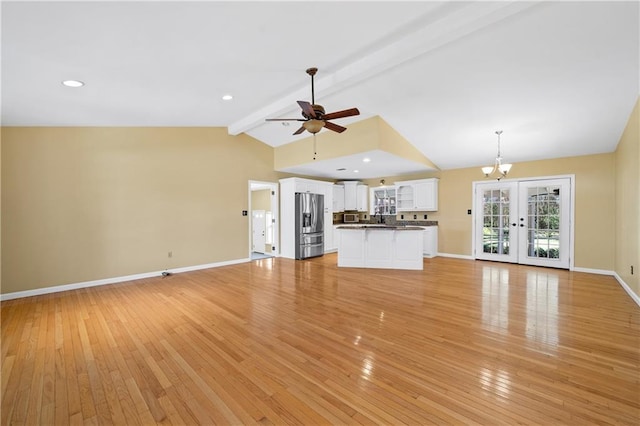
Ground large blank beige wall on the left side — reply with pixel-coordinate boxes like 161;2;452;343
1;128;278;294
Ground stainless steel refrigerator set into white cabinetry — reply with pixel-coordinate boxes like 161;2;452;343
295;192;324;259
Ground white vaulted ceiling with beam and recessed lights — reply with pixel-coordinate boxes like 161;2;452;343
1;1;640;179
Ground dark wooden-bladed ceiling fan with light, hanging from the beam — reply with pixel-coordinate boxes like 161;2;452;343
266;68;360;135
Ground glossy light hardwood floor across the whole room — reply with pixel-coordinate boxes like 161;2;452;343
1;255;640;425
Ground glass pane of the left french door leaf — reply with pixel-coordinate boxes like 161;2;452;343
482;189;509;254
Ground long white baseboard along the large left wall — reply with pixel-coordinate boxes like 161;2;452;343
0;258;251;301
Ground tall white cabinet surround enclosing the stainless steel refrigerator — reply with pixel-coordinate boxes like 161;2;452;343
280;178;335;259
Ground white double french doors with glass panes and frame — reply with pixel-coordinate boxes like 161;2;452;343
474;177;573;269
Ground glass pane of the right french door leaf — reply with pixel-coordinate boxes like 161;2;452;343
527;186;560;259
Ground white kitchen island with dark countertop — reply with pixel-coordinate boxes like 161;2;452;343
338;225;424;270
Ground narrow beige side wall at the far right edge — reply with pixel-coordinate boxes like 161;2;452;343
615;101;640;296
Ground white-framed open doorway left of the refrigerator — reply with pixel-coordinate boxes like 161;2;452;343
249;181;279;260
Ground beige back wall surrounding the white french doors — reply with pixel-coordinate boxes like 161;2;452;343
367;154;615;271
